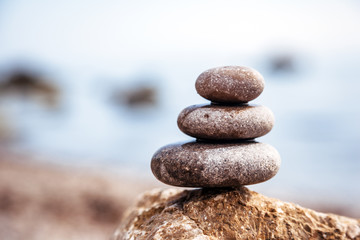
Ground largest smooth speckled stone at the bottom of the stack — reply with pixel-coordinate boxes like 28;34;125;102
151;141;281;187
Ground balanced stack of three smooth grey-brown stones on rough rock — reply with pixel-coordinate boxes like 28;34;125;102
151;66;280;187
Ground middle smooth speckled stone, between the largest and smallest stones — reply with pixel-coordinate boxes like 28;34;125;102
177;104;274;140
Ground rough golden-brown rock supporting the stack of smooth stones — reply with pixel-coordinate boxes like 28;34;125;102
113;187;360;240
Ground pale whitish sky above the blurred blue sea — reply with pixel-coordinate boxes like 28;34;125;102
0;0;360;71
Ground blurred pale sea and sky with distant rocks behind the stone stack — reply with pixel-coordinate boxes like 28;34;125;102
0;0;360;238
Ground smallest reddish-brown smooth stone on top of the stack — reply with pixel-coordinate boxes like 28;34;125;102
195;66;265;103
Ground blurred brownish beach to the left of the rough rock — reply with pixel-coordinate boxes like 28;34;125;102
0;153;156;240
